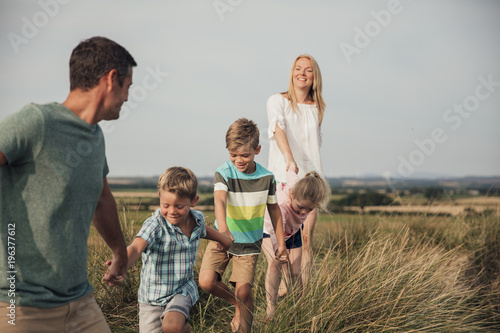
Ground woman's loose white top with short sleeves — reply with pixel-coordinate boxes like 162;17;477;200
267;94;323;182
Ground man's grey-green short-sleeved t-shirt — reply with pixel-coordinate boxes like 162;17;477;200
0;103;108;308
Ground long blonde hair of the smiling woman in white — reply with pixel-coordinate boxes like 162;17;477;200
286;54;325;126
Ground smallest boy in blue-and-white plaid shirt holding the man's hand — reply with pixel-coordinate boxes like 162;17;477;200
108;167;232;333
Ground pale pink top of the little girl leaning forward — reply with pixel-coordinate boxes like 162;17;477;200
264;170;309;250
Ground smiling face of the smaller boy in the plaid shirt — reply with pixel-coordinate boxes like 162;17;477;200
160;191;199;226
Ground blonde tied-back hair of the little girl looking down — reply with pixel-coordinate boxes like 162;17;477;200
292;171;330;210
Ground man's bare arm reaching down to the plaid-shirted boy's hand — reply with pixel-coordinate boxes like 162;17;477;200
94;177;127;286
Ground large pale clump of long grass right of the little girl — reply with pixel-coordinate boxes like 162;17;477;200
265;229;488;332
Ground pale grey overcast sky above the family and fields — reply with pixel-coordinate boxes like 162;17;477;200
0;0;500;178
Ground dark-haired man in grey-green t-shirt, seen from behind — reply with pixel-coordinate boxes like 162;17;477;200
0;37;137;332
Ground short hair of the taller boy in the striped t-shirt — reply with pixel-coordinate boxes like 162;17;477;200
226;118;260;150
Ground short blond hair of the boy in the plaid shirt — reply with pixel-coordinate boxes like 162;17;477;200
158;167;198;200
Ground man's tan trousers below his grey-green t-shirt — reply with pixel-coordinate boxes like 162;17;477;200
0;294;111;333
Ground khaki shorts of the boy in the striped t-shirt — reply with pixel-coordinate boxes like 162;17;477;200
200;241;259;286
